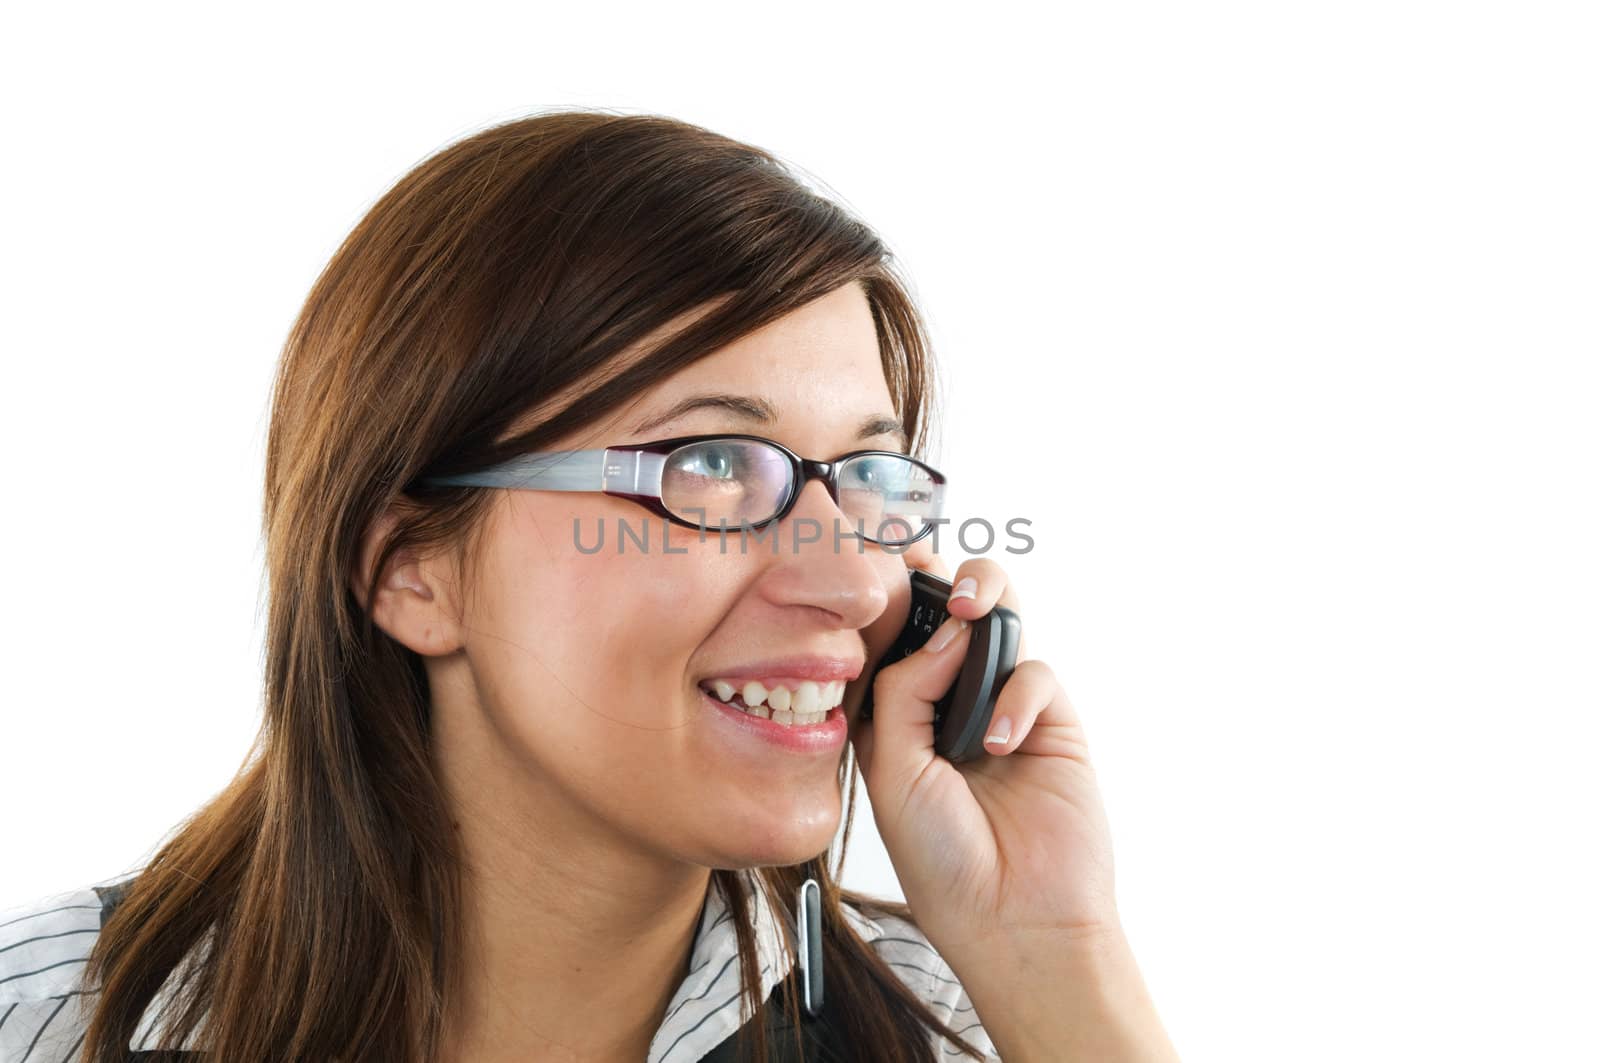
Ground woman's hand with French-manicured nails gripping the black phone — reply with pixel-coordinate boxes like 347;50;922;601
851;548;1120;953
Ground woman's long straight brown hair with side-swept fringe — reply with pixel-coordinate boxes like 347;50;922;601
85;110;981;1063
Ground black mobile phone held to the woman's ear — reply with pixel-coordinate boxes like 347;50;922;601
861;568;1022;764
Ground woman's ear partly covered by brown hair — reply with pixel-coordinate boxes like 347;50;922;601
350;507;466;656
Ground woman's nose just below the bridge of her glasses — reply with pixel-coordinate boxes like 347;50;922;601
760;480;888;629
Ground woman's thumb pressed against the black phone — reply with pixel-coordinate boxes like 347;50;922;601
856;616;971;808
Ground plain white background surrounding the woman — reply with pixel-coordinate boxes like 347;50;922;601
0;2;1600;1061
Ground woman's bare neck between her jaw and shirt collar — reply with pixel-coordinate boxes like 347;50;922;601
435;685;710;1063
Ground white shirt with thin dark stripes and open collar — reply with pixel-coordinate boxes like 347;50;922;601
0;871;1000;1063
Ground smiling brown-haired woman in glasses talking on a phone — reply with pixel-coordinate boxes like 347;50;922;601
0;112;1170;1063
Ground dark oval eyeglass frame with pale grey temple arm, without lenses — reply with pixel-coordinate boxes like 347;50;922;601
416;432;946;548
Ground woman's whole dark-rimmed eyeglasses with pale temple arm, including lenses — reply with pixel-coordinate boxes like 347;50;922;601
419;435;944;546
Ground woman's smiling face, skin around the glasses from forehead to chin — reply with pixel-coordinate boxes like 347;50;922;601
429;285;909;868
